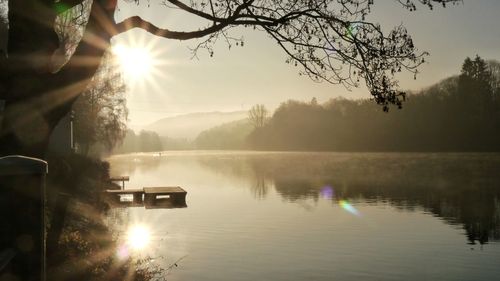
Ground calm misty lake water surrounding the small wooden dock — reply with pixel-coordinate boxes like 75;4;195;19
110;152;500;281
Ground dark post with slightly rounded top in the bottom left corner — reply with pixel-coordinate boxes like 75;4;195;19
0;155;48;281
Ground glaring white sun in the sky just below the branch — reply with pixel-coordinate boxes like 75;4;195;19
113;44;153;79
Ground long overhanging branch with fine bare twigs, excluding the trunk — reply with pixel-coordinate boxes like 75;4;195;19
111;0;460;110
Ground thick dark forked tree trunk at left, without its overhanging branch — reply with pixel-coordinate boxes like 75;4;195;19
0;0;115;158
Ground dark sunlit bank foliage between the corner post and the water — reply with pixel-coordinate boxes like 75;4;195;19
47;154;165;281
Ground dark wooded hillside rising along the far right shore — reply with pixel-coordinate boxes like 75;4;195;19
247;56;500;151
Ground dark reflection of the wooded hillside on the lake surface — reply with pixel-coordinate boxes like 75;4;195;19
193;153;500;244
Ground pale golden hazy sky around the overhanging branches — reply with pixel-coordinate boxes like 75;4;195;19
115;0;500;127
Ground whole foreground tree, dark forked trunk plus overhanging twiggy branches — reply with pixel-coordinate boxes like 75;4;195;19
0;0;459;157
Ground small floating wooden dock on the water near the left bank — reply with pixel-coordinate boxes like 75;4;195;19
106;186;187;209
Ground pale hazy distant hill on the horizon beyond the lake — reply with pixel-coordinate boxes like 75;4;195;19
142;111;248;140
